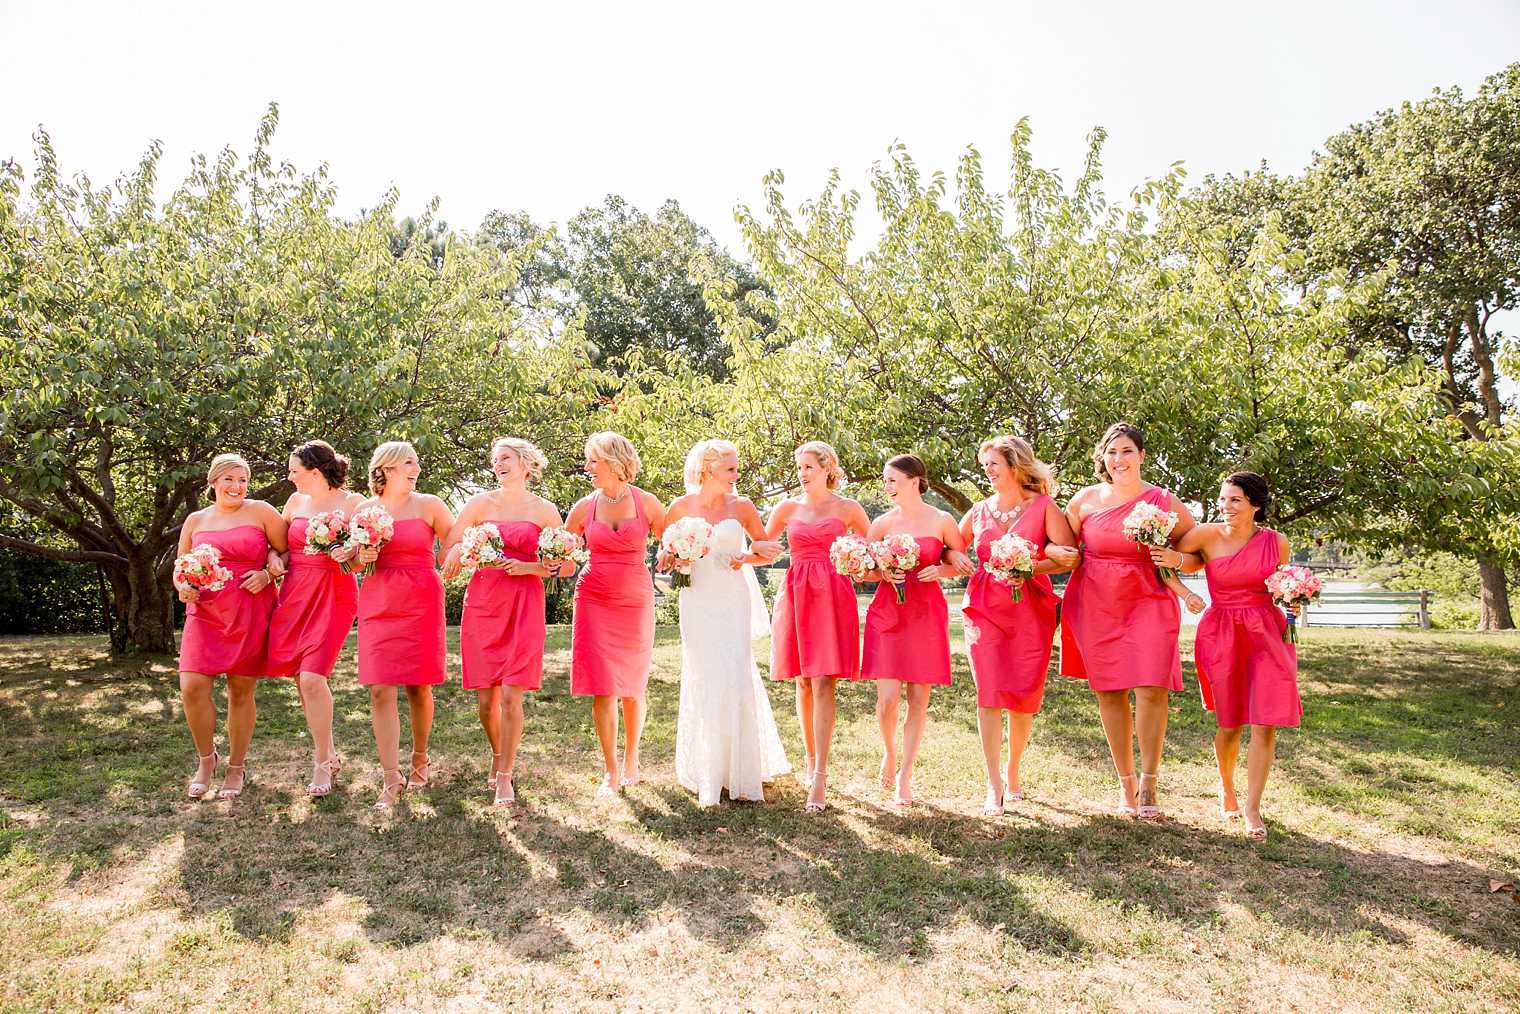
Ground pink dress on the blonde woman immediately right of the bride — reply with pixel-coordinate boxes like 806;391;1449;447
771;517;860;680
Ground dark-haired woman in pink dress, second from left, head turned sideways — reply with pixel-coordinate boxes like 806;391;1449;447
269;439;363;798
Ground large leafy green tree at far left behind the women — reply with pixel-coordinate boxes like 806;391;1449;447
0;108;590;651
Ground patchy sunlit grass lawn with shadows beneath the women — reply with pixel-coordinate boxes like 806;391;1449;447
0;628;1520;1011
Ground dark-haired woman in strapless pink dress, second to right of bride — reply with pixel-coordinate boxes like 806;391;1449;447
860;455;971;806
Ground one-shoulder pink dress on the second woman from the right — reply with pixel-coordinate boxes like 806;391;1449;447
1061;490;1183;690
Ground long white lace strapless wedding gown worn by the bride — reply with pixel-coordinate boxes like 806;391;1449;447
675;518;792;806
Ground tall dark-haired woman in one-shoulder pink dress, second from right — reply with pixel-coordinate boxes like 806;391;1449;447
1047;423;1204;819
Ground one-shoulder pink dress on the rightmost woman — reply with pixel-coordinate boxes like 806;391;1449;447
1193;528;1304;728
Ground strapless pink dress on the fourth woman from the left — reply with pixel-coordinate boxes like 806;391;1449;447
459;521;544;690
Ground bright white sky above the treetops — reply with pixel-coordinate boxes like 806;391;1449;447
0;0;1520;248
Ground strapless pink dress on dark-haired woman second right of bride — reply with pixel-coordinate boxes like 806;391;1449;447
860;535;950;684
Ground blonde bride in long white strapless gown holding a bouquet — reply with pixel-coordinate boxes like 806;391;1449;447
660;439;790;806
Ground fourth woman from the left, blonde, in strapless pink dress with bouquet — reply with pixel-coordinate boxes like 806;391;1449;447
444;436;570;806
